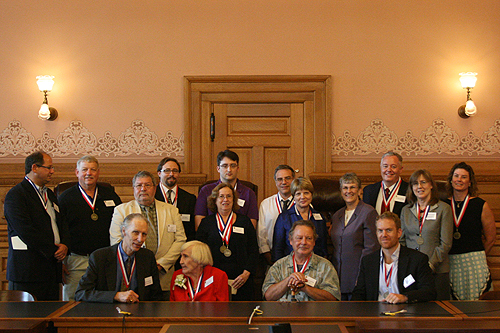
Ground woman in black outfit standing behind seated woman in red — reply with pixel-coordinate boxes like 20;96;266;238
196;183;259;301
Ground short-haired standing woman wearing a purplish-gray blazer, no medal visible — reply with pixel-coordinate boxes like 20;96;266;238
330;173;380;301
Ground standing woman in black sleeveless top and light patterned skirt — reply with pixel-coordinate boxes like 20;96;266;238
446;162;496;300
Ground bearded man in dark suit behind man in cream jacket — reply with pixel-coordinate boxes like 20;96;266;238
155;157;196;241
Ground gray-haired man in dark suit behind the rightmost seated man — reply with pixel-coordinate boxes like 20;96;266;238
363;151;408;216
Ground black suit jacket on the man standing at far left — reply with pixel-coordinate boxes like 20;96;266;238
4;178;69;282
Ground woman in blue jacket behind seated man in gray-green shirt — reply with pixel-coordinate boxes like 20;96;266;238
271;177;328;262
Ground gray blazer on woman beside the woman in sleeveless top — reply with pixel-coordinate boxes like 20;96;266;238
399;201;453;273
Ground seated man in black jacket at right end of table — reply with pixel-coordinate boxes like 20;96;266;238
351;212;436;304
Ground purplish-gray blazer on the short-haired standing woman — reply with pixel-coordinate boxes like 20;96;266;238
330;201;380;293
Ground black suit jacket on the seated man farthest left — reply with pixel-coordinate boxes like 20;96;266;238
75;243;162;303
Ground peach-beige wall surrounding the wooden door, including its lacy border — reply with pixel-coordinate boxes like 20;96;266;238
0;0;500;163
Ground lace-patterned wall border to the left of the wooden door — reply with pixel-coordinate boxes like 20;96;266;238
0;120;184;157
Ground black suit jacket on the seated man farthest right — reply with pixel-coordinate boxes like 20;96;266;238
352;245;436;303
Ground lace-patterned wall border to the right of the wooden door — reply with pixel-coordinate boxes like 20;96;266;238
332;119;500;156
